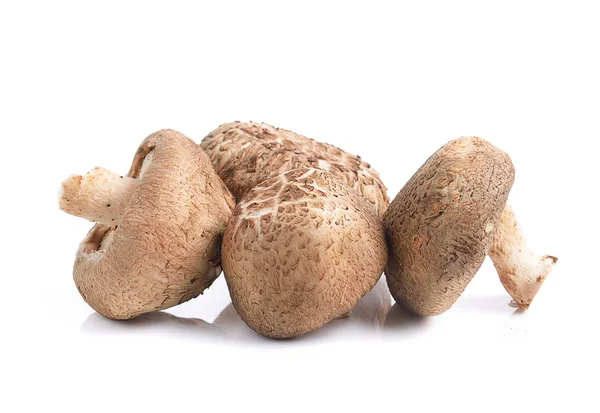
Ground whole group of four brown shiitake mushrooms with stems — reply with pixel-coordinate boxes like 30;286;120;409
59;122;556;338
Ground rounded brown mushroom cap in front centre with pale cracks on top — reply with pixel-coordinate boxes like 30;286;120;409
222;168;387;338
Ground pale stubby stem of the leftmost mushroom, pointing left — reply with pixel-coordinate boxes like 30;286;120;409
58;167;140;226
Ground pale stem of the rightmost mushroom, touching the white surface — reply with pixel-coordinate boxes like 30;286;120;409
488;204;557;310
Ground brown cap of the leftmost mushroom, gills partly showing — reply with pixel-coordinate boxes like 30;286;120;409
73;130;234;319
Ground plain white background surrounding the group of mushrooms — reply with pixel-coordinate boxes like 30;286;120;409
0;1;600;412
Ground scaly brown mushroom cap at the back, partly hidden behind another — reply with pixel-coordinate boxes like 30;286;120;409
200;122;390;215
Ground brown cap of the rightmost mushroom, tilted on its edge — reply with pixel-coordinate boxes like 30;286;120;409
383;137;514;315
